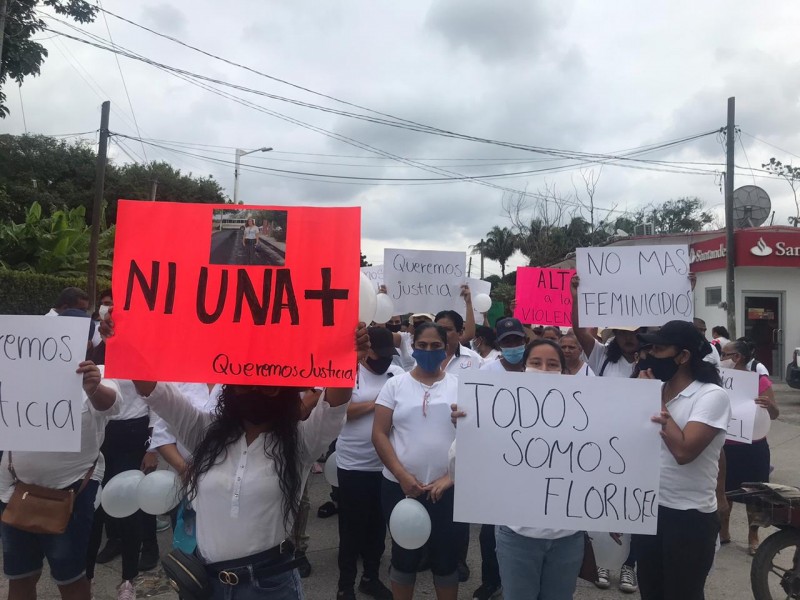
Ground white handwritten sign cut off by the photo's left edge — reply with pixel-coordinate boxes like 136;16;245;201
0;315;89;452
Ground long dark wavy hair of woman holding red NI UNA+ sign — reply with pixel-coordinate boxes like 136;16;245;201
183;385;303;527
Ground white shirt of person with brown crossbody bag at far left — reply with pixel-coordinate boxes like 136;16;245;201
0;376;121;502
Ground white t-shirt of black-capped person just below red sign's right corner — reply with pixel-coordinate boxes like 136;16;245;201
336;364;405;471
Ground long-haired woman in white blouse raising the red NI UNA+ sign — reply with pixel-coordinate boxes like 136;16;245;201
131;324;369;600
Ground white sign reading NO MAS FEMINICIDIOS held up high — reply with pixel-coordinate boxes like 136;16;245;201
575;245;694;327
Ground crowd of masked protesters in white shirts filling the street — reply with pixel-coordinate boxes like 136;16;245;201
0;239;779;600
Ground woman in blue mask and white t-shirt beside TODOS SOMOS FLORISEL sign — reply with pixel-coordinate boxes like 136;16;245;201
372;323;468;600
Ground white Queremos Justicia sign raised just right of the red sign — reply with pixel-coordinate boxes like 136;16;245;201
383;248;467;315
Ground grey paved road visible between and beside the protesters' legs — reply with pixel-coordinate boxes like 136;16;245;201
0;385;800;600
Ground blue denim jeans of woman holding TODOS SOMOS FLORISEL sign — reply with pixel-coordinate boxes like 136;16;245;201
495;526;583;600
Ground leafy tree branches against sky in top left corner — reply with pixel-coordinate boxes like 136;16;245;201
0;0;97;118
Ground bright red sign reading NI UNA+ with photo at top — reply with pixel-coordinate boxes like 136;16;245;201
106;200;361;387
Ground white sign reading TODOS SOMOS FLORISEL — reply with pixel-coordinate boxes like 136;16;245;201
454;371;661;534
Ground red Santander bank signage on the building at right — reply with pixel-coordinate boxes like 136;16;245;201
689;229;800;272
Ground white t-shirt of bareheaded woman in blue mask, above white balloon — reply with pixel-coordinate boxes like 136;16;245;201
375;373;458;485
